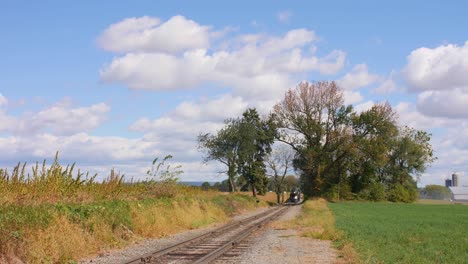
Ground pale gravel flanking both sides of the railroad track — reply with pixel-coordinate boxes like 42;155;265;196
79;205;337;264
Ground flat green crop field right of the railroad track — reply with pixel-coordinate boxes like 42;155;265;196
329;202;468;263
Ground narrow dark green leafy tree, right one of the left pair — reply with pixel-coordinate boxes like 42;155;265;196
237;108;276;197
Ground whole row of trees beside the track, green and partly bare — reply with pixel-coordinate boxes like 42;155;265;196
198;81;435;202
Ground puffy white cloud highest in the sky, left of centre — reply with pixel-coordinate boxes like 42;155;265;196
98;16;210;53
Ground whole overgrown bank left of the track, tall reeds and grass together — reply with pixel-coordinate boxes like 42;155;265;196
0;157;265;263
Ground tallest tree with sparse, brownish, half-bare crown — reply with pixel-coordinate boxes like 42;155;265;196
272;82;352;196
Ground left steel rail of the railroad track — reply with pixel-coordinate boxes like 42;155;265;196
123;208;277;264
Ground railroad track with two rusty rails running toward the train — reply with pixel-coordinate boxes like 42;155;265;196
124;207;288;264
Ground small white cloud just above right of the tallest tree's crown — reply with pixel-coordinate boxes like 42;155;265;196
338;64;379;90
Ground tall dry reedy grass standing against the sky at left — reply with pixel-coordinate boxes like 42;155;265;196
0;156;205;206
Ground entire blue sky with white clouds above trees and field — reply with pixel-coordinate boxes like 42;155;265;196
0;1;468;185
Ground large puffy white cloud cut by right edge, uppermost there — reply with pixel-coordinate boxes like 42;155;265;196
403;41;468;91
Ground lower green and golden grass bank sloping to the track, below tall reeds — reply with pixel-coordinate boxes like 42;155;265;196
0;193;258;263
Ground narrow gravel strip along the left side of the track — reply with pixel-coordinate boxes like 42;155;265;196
79;208;269;264
